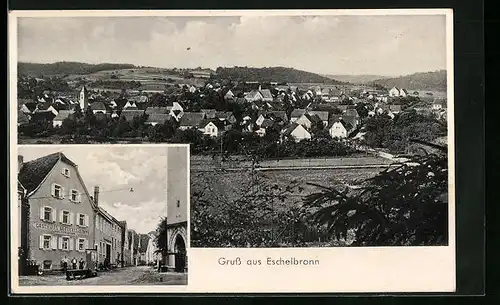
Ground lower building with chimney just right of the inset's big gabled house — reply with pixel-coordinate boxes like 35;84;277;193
94;186;123;266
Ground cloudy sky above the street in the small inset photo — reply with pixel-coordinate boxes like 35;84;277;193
18;145;187;234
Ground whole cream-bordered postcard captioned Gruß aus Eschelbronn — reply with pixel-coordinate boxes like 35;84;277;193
9;9;456;294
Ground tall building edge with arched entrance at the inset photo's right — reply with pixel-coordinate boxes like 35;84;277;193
167;147;189;272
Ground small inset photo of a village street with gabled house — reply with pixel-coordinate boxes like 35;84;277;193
11;145;189;286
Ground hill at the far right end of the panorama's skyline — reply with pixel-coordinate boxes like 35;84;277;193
372;70;447;91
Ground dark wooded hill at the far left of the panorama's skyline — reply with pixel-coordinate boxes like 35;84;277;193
17;61;135;77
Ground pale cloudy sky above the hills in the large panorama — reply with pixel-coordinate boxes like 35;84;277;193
18;15;446;76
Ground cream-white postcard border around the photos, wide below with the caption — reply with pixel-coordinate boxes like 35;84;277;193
8;9;456;294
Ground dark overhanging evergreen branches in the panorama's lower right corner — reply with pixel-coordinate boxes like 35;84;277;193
303;148;448;246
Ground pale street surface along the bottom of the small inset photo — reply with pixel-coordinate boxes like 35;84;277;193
19;266;187;286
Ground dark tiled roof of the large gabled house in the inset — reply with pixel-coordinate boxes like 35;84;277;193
18;152;76;194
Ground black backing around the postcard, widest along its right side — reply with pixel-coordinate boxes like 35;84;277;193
3;0;486;304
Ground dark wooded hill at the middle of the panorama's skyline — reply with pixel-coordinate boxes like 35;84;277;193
216;67;344;85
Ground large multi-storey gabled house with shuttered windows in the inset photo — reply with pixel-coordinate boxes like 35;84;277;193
18;152;96;270
